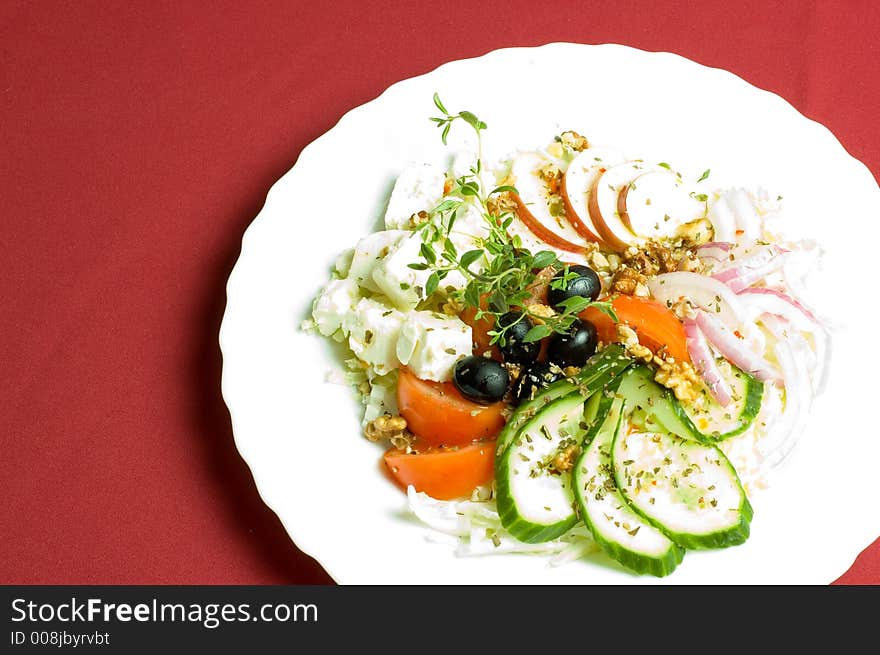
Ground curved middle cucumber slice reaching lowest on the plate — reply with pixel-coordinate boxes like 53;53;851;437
572;394;685;577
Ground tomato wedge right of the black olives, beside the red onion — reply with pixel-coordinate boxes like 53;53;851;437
579;295;690;362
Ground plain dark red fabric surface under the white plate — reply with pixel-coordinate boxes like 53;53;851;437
0;0;880;584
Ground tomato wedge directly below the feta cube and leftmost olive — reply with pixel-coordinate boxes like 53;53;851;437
397;368;506;446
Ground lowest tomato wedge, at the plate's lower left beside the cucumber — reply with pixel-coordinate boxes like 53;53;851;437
384;441;495;500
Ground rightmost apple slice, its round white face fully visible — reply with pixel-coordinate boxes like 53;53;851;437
617;168;706;238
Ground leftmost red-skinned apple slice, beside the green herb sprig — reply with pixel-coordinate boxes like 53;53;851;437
510;152;587;253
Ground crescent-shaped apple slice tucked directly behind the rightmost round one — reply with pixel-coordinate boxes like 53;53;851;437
587;160;656;251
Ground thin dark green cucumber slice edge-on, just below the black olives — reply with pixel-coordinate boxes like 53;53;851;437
495;344;633;459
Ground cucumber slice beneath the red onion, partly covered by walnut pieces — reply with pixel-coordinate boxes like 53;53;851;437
677;364;764;441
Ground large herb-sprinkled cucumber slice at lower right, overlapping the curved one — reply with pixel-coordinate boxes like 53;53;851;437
611;431;752;548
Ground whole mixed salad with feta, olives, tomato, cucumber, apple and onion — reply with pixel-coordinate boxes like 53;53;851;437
305;94;829;576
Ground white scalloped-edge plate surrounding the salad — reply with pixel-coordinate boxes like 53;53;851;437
220;43;880;584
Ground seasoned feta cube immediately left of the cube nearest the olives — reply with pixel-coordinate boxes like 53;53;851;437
342;298;404;375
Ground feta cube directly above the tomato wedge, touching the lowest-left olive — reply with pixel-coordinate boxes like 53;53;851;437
397;311;473;382
